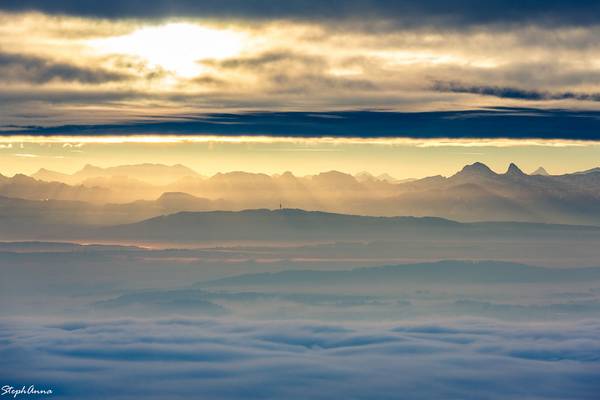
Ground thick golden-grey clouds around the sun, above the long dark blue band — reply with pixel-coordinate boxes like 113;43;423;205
0;0;600;126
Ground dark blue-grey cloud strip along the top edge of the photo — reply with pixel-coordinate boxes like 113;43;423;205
0;0;600;28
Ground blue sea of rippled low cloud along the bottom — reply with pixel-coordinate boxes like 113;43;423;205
0;319;600;399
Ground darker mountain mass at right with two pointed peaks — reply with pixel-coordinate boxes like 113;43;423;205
390;163;600;224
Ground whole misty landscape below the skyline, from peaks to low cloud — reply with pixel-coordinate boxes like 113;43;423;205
0;163;600;399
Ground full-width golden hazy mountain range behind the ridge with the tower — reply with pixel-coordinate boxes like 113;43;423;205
0;163;600;225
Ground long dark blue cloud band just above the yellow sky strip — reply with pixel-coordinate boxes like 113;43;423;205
2;108;600;140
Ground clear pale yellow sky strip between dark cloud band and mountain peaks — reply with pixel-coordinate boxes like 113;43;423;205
0;137;600;179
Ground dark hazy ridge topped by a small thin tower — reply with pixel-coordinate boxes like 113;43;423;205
94;209;600;243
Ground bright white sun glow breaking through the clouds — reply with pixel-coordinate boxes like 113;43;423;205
89;23;244;78
